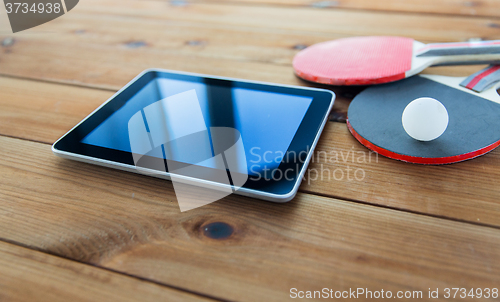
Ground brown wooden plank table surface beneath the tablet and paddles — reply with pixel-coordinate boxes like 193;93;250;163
0;0;500;301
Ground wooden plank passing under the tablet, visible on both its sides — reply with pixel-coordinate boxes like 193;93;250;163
0;77;500;226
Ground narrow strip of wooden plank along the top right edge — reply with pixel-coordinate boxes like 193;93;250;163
189;0;500;18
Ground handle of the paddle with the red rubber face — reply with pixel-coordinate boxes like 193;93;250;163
416;40;500;58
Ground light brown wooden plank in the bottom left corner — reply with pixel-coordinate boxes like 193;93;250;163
0;242;212;302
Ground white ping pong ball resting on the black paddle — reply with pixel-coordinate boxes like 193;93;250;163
402;97;449;142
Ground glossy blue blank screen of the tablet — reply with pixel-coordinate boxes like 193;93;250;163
82;78;313;174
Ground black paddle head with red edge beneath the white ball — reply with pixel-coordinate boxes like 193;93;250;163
347;76;500;164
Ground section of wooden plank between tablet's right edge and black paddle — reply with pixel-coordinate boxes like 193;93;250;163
301;123;500;226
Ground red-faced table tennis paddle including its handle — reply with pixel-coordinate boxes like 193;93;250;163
293;36;500;85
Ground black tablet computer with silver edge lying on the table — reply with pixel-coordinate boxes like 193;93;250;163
52;69;335;202
